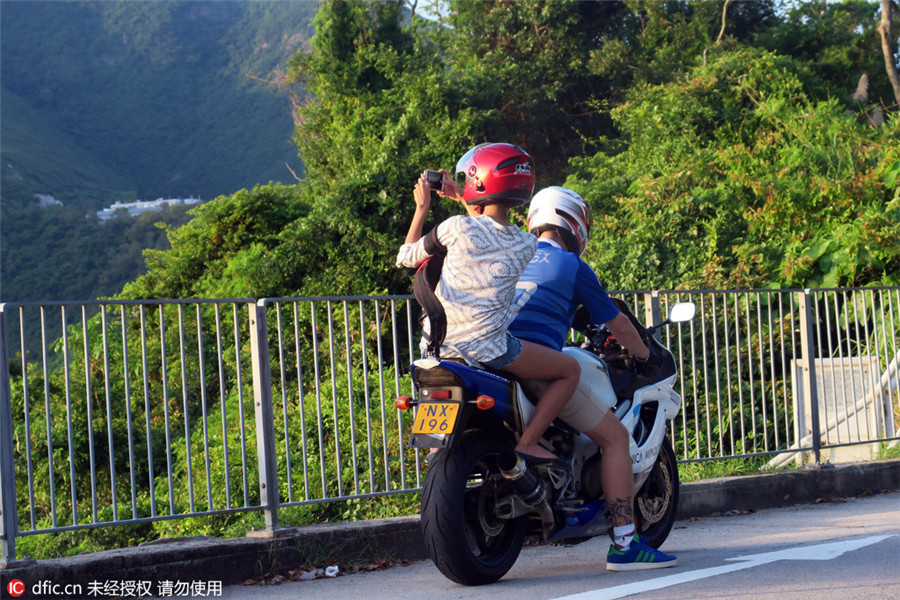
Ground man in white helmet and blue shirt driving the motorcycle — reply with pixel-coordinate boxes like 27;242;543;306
509;186;678;571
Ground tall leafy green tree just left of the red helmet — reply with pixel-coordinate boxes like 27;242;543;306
285;0;471;295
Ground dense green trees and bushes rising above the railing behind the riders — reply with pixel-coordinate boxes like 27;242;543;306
5;0;900;564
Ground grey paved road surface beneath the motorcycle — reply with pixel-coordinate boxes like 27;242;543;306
223;493;900;600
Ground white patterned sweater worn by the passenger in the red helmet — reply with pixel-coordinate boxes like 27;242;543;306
397;216;537;362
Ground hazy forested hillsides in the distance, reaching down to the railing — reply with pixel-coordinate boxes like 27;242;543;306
0;0;318;301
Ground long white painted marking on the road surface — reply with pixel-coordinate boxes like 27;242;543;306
556;535;892;600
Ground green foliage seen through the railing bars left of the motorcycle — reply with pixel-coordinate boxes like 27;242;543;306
9;302;417;558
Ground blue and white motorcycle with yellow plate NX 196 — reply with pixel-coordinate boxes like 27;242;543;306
395;299;695;585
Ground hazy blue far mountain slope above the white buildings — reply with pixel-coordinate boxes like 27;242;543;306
0;1;316;209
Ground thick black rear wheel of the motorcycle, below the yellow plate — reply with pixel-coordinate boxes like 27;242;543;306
421;432;528;585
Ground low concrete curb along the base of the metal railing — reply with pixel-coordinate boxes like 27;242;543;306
0;460;900;598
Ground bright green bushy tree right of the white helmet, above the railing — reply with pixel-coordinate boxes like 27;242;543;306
568;49;900;289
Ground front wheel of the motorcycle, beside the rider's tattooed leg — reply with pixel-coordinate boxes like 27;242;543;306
634;437;679;548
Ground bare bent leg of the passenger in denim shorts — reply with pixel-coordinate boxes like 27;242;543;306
503;340;580;464
